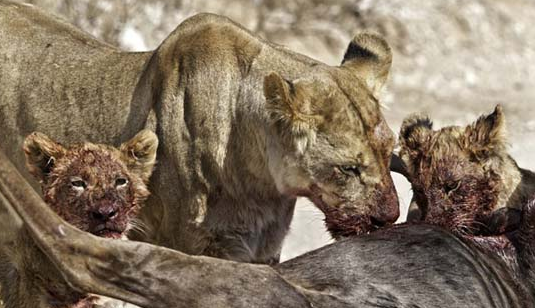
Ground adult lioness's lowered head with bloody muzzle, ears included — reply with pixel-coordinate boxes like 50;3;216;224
264;33;399;237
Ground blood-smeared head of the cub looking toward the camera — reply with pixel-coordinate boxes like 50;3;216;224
24;130;158;238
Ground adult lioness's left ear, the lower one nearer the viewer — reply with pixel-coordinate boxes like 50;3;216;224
264;73;317;153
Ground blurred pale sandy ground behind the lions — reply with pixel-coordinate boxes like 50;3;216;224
15;0;535;259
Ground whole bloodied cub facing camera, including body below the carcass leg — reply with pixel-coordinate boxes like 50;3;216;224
0;130;158;308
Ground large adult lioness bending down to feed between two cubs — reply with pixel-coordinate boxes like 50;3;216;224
0;1;399;262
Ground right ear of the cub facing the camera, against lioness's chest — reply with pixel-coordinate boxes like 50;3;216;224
119;129;158;183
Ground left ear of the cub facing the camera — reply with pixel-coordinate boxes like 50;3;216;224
22;132;67;181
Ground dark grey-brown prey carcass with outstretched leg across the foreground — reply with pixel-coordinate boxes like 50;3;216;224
0;152;535;308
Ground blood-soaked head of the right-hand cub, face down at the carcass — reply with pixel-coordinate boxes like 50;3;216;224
400;106;518;234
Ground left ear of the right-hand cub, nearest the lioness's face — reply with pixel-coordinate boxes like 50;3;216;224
399;114;433;163
